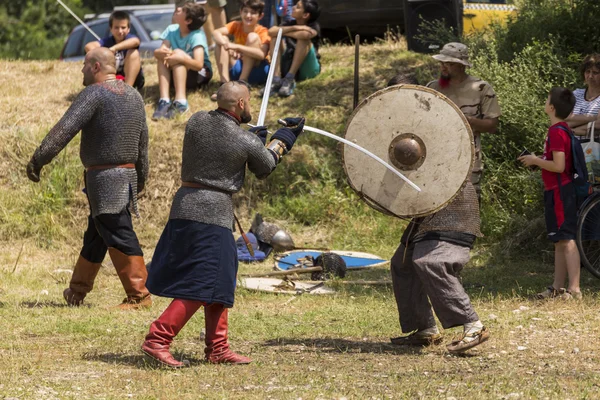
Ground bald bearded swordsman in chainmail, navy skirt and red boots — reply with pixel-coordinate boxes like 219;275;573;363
142;81;304;368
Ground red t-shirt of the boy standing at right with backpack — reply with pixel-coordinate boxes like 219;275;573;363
542;122;573;190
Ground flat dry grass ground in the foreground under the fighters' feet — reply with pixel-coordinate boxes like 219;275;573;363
0;245;600;399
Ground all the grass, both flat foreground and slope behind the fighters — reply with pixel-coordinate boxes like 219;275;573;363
0;41;600;399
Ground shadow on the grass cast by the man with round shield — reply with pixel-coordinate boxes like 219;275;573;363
263;338;421;355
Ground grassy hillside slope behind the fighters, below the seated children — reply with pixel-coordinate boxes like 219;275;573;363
0;41;428;256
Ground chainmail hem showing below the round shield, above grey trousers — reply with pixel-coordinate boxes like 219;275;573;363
415;182;483;237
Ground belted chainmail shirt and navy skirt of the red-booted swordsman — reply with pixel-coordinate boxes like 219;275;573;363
146;110;277;307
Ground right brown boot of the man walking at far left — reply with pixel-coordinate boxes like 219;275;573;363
108;247;152;310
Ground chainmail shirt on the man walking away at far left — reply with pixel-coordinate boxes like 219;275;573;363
32;80;148;217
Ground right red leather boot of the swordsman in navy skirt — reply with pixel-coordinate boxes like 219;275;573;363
204;303;252;364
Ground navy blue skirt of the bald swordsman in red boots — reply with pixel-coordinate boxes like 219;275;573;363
146;219;238;307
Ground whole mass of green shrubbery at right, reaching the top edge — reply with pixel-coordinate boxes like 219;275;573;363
416;0;588;255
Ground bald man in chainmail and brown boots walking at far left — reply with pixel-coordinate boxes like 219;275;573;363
27;47;152;309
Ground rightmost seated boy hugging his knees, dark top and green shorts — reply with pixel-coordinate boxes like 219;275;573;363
262;0;321;97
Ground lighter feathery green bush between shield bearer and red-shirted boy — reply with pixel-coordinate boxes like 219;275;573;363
471;40;577;247
